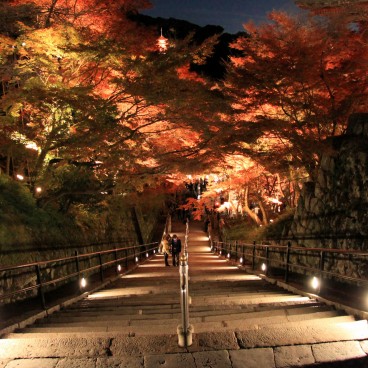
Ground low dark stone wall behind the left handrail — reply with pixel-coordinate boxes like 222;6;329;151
0;209;164;304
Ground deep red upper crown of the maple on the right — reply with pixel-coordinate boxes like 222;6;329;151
226;12;368;178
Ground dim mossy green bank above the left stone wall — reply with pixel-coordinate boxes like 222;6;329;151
0;175;164;252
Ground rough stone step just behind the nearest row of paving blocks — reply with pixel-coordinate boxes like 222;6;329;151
2;320;368;357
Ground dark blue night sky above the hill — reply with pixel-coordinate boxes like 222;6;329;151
144;0;300;33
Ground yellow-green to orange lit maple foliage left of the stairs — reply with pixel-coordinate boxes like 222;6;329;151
1;0;230;213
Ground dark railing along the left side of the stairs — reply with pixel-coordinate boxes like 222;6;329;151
0;242;158;309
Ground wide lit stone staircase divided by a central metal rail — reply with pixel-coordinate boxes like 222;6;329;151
0;224;368;368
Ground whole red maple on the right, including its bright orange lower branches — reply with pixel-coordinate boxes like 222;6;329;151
178;11;368;223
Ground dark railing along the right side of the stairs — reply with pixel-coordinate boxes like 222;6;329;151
211;241;368;294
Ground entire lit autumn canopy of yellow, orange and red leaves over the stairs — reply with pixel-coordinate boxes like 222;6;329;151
0;0;368;229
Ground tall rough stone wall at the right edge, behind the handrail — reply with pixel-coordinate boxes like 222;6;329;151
288;114;368;278
